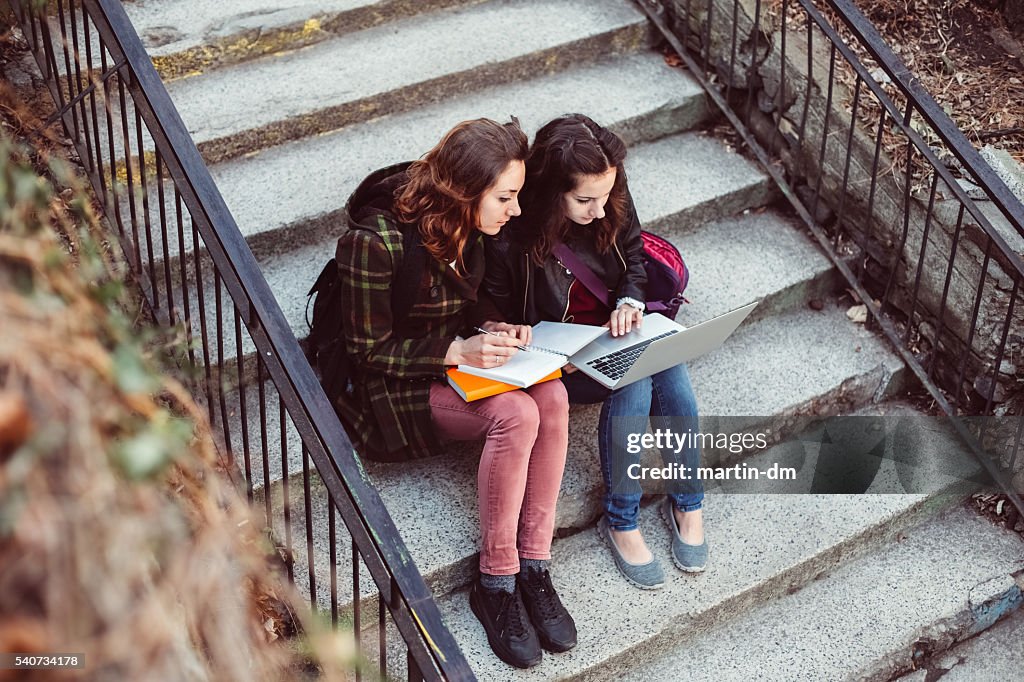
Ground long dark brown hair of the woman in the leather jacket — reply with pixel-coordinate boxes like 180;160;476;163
518;114;627;264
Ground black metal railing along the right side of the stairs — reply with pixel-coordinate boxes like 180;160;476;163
638;0;1024;512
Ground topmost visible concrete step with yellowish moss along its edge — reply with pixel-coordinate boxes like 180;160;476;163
125;0;483;81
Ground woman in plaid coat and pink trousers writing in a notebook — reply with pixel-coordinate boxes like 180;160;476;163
336;119;577;668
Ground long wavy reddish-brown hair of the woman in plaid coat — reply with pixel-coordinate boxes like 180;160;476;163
395;118;529;272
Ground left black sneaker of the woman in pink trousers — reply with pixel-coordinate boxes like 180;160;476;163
469;581;543;668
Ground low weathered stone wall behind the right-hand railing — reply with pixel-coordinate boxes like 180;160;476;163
662;0;1024;414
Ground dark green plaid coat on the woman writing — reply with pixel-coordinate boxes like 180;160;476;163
335;164;485;461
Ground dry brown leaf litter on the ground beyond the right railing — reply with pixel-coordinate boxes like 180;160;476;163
766;0;1024;194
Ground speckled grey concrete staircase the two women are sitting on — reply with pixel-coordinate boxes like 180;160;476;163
112;0;1024;680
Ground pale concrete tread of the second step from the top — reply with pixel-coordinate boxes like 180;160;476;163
168;0;644;151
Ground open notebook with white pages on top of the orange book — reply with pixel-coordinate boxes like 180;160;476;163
459;322;608;388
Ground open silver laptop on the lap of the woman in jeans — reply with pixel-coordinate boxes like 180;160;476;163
569;301;760;388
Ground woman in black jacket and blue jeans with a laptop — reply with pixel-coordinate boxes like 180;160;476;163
484;114;708;589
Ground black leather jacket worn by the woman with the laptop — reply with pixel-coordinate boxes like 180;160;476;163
483;195;647;325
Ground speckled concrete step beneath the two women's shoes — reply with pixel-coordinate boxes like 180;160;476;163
438;495;991;681
